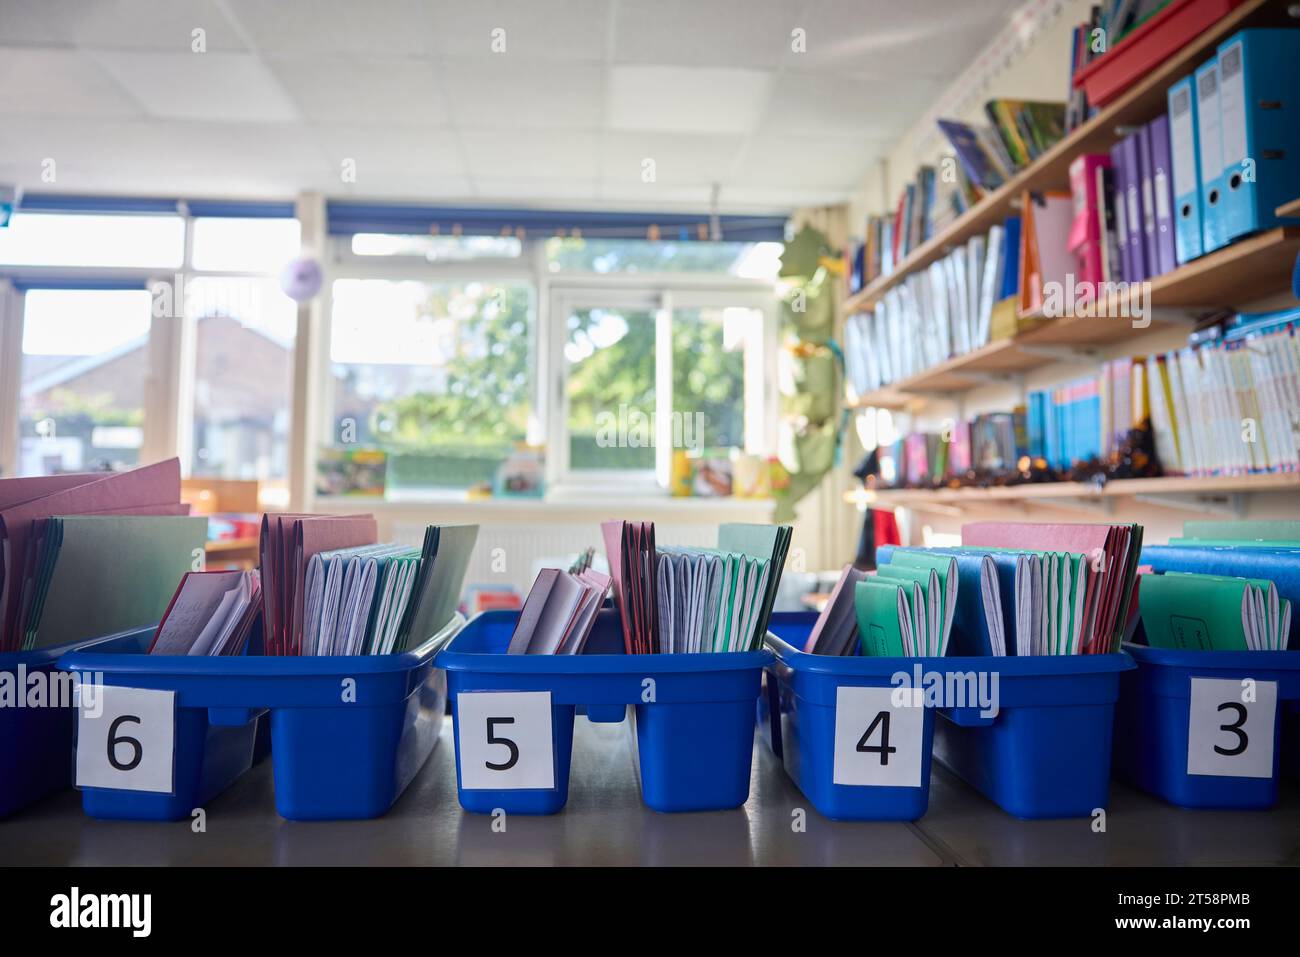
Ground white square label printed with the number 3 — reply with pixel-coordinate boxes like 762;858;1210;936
1187;677;1278;778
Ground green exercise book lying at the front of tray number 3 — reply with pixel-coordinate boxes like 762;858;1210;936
1139;572;1291;651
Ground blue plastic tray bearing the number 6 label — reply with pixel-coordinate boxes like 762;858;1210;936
59;616;464;820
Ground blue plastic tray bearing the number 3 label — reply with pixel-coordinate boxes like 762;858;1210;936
1115;645;1300;809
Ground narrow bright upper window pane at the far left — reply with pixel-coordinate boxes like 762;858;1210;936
0;213;185;269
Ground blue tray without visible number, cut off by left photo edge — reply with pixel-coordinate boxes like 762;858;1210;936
0;633;148;819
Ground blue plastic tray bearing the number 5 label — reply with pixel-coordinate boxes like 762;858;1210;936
436;609;772;814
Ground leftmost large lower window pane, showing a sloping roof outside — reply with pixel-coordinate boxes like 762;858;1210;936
18;289;151;475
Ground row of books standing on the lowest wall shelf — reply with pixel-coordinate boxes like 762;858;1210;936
881;308;1300;488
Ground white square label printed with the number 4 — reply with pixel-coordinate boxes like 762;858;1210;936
832;688;926;788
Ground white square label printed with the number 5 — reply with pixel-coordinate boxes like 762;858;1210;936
456;692;555;791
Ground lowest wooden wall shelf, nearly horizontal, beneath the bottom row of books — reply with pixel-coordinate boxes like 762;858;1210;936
844;472;1300;508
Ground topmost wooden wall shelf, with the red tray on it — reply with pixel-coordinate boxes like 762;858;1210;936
845;0;1287;312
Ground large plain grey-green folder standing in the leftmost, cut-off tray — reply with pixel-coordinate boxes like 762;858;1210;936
23;515;208;650
